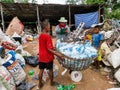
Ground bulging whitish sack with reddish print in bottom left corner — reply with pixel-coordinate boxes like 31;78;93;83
0;66;16;90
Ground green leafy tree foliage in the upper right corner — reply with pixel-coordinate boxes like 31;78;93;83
85;0;120;19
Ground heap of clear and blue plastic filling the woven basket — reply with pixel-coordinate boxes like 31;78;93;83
56;40;97;59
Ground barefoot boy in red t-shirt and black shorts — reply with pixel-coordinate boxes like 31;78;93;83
39;20;62;88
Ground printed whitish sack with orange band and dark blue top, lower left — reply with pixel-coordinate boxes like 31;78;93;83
3;60;26;85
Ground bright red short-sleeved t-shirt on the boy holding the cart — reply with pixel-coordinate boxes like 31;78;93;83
39;34;54;63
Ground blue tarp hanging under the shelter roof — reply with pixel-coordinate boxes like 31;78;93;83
74;11;98;28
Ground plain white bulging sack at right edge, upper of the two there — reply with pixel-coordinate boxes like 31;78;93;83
107;48;120;68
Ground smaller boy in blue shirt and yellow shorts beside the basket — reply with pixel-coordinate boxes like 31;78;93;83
92;25;103;69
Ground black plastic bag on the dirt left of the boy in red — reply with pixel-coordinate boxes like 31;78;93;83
24;56;39;67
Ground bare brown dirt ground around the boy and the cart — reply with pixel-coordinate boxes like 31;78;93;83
23;39;114;90
